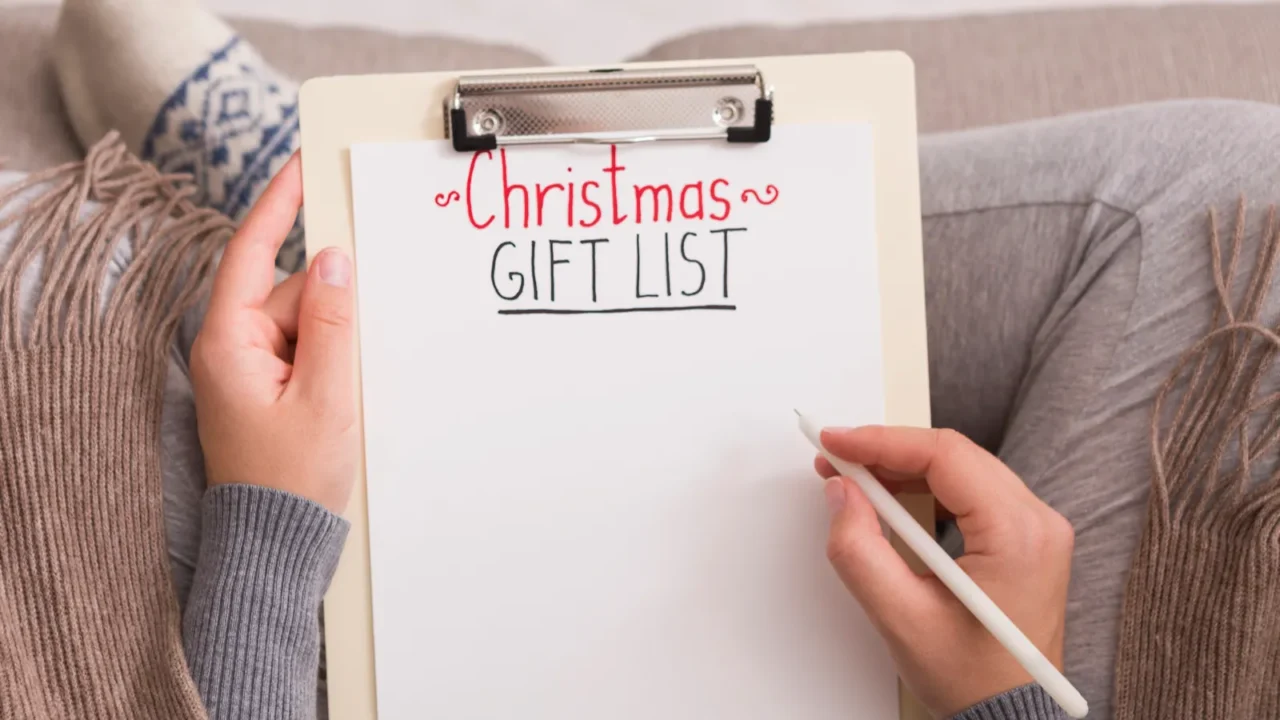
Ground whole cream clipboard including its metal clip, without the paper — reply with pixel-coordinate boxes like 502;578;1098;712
300;51;934;720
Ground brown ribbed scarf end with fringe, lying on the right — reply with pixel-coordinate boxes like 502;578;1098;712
1116;201;1280;720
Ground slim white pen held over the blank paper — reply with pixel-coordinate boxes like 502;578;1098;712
796;410;1089;717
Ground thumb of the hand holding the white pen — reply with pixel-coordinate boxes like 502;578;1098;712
824;477;931;632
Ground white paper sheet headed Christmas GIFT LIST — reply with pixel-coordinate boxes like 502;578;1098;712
352;124;897;720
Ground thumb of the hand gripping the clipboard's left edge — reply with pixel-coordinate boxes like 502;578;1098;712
289;247;356;407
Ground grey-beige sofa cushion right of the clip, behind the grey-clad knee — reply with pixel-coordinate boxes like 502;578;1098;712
634;4;1280;132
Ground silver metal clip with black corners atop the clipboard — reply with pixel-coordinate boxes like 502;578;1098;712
444;65;773;152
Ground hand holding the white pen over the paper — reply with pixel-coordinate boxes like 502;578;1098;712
815;427;1074;717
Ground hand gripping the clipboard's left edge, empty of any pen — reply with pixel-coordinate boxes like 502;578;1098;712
191;155;360;514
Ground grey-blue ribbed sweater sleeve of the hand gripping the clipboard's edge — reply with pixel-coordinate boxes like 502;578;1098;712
182;484;348;720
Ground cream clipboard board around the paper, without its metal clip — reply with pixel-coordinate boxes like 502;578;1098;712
300;53;933;720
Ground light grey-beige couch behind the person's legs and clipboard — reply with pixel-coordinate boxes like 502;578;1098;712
0;4;1280;169
